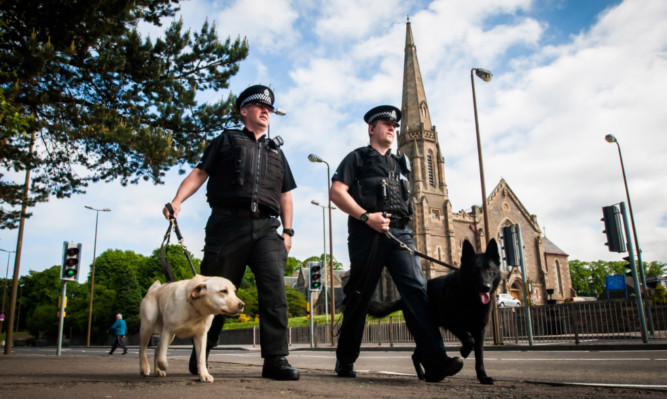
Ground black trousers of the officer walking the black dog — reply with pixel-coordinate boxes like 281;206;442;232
336;225;446;363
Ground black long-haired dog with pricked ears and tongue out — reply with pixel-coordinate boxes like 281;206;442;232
368;239;500;384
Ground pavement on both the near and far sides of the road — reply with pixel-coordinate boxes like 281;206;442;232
0;342;667;399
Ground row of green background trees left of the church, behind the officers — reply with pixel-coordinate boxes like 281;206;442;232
15;245;344;344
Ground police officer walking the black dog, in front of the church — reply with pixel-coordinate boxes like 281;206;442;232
331;105;463;382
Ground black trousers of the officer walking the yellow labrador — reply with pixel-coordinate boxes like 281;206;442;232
201;208;288;357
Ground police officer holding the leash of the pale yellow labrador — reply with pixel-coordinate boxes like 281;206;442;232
163;85;299;380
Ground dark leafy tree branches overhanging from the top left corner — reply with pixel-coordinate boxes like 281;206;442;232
0;0;248;228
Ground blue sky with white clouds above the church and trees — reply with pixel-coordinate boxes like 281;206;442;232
0;0;667;282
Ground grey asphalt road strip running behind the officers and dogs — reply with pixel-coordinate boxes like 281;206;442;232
14;346;667;391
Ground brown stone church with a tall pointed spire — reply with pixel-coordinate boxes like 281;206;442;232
376;21;574;305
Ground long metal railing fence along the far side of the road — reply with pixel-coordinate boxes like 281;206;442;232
220;299;667;346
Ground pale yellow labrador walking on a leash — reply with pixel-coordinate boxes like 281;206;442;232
139;275;245;382
